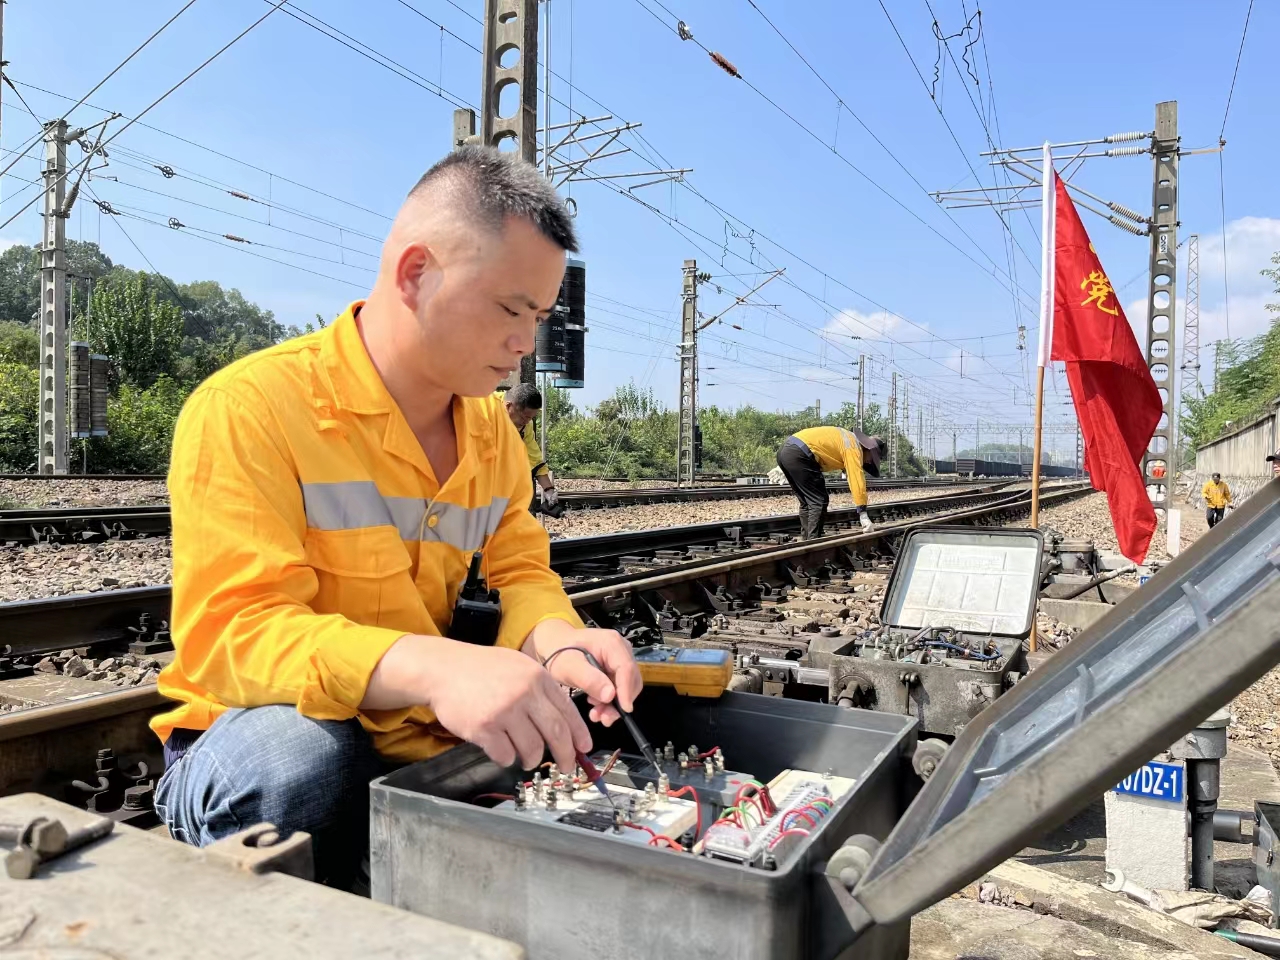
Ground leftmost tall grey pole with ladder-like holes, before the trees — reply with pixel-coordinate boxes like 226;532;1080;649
37;120;67;474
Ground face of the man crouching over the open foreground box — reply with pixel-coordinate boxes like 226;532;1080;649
415;218;564;399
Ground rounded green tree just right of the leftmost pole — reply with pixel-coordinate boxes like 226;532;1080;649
77;274;182;388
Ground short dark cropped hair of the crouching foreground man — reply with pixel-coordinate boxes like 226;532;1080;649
410;146;577;253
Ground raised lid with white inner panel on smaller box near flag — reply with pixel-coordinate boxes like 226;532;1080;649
881;526;1044;636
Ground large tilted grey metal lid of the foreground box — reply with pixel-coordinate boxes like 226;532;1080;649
852;480;1280;929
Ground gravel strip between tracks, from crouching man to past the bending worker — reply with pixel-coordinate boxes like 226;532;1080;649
541;488;968;540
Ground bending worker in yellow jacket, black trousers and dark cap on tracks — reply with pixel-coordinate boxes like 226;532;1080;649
778;426;887;540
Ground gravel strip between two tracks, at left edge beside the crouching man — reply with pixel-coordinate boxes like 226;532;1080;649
0;536;170;602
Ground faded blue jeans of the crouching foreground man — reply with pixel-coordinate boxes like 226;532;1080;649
156;704;387;888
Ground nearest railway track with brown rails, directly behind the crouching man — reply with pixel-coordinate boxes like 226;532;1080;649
0;484;1091;795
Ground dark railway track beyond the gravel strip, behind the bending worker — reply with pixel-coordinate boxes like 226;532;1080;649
0;480;988;544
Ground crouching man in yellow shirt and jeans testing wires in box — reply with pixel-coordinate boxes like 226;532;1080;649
151;147;641;884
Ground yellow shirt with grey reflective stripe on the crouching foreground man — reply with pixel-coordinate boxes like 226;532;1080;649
151;303;581;762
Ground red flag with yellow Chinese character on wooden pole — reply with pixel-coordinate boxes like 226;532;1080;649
1050;175;1164;563
